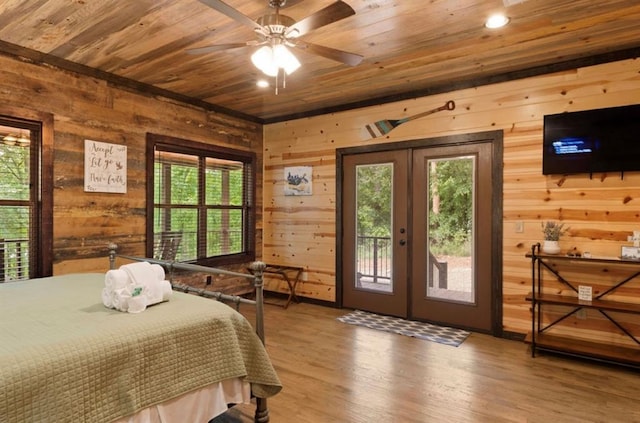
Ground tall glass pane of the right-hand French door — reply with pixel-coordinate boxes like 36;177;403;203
426;156;476;303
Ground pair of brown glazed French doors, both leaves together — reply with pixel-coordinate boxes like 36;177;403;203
339;133;501;332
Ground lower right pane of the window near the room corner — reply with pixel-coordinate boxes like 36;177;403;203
207;210;244;256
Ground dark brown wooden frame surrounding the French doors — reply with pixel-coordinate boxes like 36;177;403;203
335;130;504;336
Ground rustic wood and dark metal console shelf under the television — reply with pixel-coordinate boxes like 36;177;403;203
525;244;640;368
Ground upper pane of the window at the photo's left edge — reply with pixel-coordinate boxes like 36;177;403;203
0;143;30;201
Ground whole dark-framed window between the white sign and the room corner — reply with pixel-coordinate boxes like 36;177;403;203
147;134;255;265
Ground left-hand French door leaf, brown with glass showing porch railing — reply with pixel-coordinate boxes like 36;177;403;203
342;150;409;317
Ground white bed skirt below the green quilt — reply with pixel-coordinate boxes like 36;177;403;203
114;379;251;423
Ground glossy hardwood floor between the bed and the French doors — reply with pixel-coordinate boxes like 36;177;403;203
239;303;640;423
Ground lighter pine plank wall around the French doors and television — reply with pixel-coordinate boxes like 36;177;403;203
263;60;640;338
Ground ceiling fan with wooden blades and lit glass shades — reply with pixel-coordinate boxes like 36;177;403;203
187;0;363;84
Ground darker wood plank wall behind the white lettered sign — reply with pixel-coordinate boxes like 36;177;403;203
0;56;262;274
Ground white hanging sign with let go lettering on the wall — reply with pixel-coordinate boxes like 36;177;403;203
84;140;127;194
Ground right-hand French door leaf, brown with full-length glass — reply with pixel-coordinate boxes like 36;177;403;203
410;143;493;331
